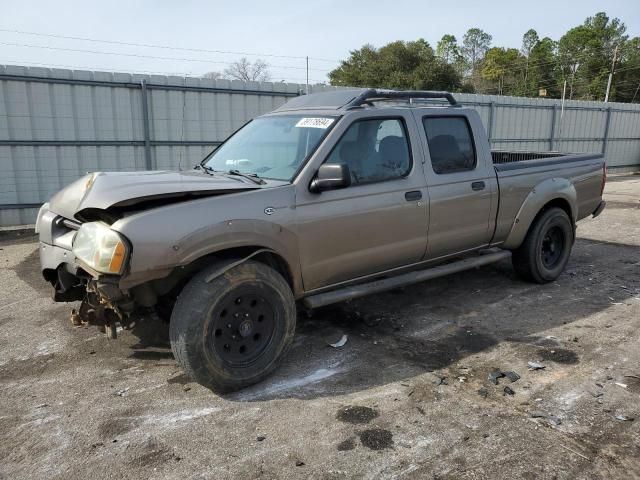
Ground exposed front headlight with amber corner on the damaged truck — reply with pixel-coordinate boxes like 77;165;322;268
73;222;128;274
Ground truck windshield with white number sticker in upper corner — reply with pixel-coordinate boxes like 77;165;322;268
203;115;336;181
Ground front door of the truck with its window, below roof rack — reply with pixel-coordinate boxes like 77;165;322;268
296;110;428;290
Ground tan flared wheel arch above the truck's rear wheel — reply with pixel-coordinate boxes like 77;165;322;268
502;178;578;249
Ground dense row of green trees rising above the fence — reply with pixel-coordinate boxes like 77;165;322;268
329;12;640;102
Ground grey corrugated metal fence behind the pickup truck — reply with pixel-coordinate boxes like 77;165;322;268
0;66;640;226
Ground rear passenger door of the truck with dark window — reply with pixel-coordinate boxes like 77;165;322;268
414;109;498;259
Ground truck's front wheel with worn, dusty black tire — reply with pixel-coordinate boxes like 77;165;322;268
169;261;296;393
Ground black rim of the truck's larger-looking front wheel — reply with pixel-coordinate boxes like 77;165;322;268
208;289;275;366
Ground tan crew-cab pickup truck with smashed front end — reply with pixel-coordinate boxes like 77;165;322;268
37;89;606;391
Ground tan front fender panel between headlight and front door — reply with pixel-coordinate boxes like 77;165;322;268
111;185;300;288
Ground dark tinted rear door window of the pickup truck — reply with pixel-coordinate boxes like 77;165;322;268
422;117;476;174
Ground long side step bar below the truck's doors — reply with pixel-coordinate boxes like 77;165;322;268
303;250;511;308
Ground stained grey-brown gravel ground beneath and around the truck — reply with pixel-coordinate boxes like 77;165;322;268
0;176;640;479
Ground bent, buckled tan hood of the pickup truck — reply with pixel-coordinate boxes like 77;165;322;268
49;170;272;221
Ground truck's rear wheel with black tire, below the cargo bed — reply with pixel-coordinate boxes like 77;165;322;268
512;207;574;283
